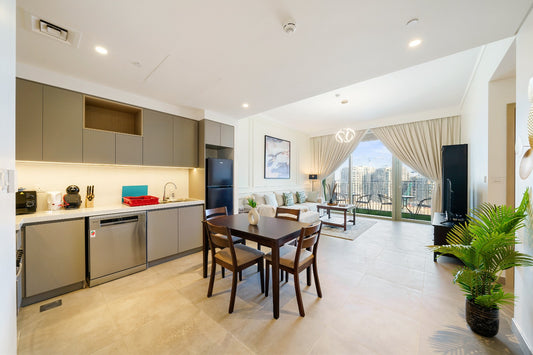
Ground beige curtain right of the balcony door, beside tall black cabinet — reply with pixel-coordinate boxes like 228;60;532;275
372;116;461;216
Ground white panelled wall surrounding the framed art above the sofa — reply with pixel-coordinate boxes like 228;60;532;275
235;116;311;202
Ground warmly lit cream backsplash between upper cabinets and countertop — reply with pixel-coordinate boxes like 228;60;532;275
15;161;189;211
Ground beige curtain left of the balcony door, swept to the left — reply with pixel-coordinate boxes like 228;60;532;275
311;130;366;180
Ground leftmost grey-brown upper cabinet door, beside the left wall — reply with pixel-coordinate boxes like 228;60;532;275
16;78;43;161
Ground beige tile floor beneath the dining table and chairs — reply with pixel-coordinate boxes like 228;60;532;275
18;220;520;354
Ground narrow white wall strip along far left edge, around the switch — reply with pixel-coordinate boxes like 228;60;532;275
0;0;17;354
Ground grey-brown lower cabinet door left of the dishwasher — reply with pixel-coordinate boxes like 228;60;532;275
23;218;85;304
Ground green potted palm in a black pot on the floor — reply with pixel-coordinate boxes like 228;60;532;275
430;190;533;337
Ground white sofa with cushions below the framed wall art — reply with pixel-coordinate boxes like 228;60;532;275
239;190;322;223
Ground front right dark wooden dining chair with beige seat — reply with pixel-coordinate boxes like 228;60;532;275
265;222;322;317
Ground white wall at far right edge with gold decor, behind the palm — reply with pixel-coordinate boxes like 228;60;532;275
514;8;533;352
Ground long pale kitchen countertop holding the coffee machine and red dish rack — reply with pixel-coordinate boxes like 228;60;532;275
16;200;204;230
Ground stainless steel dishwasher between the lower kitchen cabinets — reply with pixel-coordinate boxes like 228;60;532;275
87;212;146;287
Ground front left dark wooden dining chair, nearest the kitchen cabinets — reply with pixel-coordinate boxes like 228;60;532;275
204;220;265;313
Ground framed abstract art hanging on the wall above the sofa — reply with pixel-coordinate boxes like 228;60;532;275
265;136;291;179
